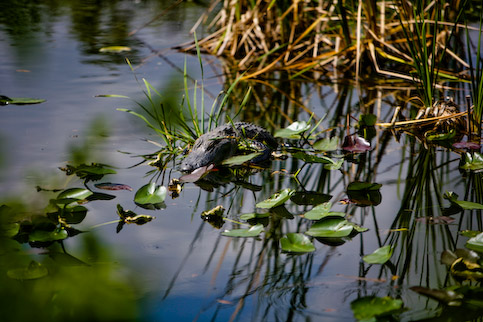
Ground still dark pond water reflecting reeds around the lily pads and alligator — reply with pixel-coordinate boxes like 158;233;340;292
0;1;483;321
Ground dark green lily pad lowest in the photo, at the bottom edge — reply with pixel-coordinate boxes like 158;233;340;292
351;296;403;321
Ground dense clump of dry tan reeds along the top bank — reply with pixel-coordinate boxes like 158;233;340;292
182;0;474;87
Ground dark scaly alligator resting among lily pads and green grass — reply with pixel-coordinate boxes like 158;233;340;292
180;122;278;173
